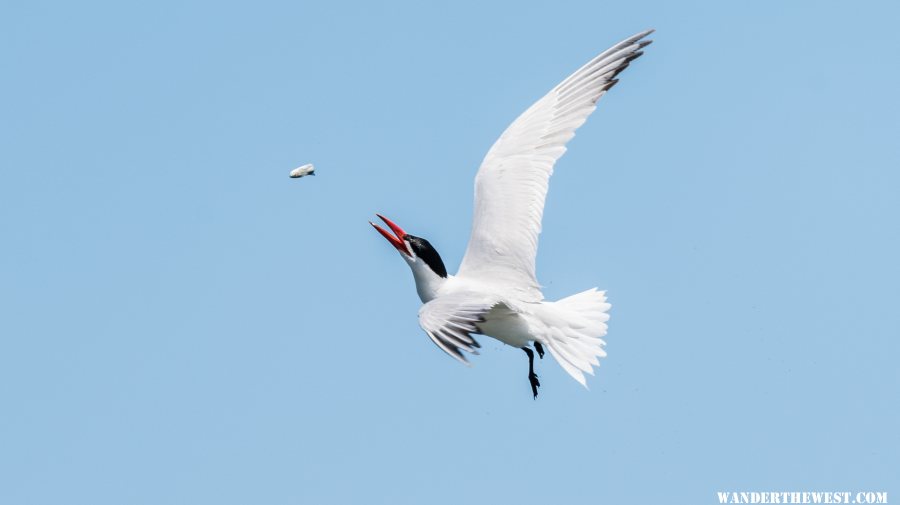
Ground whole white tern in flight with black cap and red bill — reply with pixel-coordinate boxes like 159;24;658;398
369;30;653;398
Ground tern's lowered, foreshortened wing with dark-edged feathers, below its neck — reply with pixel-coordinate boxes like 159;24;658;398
419;293;498;364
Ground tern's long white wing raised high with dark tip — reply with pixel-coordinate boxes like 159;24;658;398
458;30;653;300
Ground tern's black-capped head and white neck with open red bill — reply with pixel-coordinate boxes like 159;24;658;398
369;214;447;302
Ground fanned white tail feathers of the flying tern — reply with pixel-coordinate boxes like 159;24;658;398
538;288;611;387
